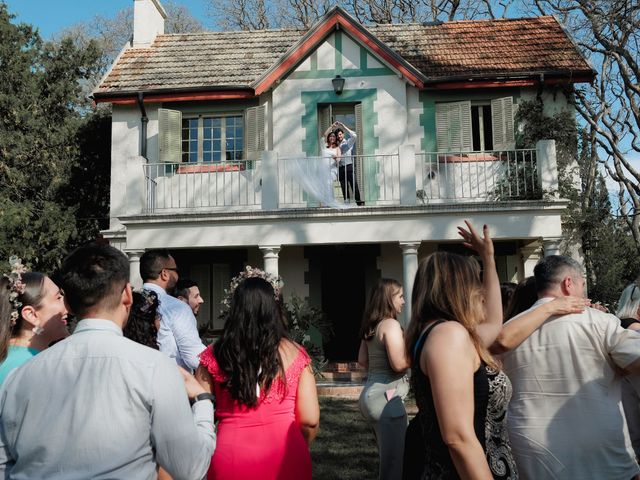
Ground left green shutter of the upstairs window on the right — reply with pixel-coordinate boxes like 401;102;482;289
436;101;473;152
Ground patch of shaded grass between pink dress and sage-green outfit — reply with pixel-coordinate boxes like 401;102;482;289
311;397;378;480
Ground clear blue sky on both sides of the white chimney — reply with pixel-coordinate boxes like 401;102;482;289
4;0;210;39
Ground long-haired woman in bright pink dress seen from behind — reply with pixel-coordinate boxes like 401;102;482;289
197;278;320;480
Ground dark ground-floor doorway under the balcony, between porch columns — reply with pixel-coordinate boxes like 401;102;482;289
305;245;380;362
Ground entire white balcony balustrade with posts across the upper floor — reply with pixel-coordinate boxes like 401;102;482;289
127;141;557;215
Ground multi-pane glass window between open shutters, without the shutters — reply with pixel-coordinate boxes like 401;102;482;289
182;115;244;163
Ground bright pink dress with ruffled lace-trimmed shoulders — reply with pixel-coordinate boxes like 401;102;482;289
200;347;311;480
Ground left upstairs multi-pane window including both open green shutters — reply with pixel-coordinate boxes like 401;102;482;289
158;106;265;163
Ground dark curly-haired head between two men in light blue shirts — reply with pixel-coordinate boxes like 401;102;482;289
122;290;160;350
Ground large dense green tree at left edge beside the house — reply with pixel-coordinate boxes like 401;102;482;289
0;3;99;271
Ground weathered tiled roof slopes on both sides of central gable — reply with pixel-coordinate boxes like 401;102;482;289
95;17;591;95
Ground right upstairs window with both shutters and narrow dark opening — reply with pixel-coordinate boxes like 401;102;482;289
436;97;515;152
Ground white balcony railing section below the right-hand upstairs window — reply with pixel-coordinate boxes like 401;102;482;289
416;149;542;203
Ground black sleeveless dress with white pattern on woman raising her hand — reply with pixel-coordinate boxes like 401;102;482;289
403;321;518;480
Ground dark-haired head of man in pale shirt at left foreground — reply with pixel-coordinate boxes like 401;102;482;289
60;243;129;318
